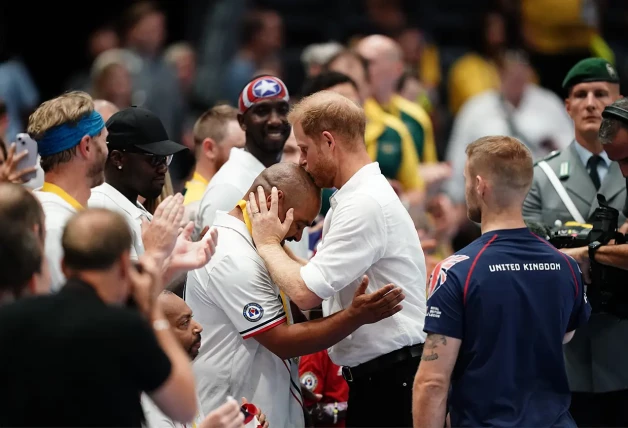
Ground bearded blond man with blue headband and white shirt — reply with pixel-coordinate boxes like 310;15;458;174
28;91;108;291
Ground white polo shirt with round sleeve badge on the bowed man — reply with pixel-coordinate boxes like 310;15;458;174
185;211;304;427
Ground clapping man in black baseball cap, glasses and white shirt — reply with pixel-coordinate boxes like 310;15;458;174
88;107;215;276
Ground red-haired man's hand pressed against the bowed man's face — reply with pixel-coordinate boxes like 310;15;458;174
246;186;293;249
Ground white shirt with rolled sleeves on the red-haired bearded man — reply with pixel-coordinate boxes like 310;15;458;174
301;162;426;367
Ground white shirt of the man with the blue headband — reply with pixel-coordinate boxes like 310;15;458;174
33;190;77;292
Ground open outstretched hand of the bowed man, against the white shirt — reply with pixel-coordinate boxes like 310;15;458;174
348;275;406;324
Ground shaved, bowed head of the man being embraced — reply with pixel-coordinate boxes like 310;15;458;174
244;163;321;241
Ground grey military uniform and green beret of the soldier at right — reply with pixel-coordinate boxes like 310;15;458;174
523;58;628;426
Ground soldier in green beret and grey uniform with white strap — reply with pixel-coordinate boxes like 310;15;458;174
523;58;628;427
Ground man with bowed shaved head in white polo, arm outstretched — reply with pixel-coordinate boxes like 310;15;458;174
185;163;404;427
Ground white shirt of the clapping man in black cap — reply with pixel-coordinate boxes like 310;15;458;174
87;183;153;260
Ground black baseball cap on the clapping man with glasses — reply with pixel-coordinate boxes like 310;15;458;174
105;106;187;156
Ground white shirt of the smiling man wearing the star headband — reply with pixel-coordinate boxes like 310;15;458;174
196;147;265;232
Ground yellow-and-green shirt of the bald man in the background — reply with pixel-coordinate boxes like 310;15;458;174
386;94;438;163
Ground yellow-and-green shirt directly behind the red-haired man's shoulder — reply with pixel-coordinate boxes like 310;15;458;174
364;99;425;191
